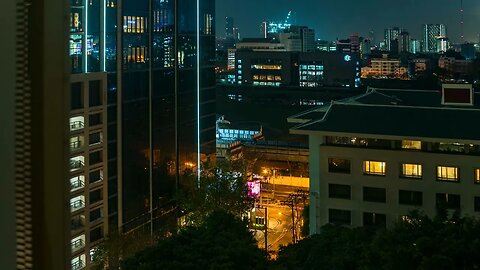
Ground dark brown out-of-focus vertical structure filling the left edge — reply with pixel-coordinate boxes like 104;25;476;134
0;0;71;270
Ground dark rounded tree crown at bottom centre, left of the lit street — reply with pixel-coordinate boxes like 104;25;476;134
122;211;267;270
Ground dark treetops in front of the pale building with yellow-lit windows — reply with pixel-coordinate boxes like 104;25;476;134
273;212;480;270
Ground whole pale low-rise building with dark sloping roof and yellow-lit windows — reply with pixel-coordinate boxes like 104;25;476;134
289;84;480;234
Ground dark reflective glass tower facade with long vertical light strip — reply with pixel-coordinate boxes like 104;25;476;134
118;0;215;236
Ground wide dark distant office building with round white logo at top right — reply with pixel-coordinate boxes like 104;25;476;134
236;50;361;88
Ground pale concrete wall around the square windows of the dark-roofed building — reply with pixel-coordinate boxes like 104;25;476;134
316;144;480;229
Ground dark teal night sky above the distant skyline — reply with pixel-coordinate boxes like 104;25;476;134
216;0;480;42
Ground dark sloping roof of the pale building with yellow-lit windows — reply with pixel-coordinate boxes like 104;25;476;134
288;86;480;141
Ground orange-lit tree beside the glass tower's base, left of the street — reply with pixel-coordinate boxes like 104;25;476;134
177;159;254;225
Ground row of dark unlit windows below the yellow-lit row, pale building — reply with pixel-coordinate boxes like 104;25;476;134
328;184;480;211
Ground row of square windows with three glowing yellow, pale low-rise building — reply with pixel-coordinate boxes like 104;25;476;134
328;158;480;183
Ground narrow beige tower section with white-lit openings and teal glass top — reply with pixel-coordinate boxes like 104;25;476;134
69;0;110;269
